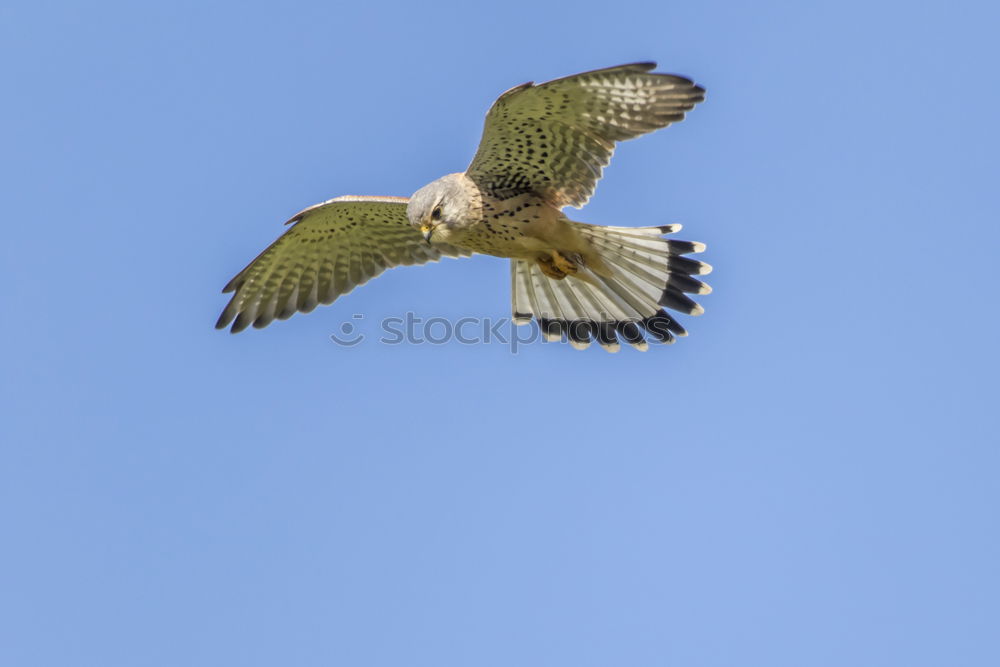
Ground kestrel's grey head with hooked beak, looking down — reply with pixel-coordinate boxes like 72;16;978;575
406;174;478;243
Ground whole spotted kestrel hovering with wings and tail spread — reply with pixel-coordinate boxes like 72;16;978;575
216;63;711;352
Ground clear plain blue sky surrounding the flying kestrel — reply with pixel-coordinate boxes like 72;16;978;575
0;1;1000;667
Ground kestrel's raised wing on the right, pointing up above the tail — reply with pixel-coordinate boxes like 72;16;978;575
466;63;705;208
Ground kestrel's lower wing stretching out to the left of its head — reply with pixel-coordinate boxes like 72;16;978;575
215;197;471;333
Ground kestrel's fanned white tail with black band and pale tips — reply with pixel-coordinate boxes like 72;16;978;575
510;223;712;352
